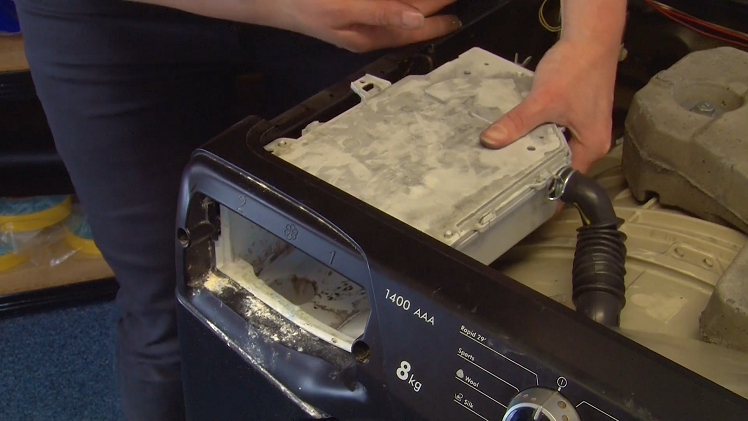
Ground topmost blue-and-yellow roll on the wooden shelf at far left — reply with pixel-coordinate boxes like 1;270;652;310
0;196;73;232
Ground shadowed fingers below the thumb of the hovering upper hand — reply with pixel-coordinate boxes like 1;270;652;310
339;16;462;53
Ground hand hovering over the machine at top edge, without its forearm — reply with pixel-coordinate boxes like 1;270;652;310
256;0;461;53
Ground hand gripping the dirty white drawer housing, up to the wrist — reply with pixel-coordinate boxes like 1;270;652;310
481;39;619;173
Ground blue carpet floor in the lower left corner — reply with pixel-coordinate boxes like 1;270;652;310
0;303;120;421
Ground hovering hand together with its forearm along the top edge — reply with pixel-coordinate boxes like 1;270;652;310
144;0;461;53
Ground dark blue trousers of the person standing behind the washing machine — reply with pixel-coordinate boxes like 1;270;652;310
17;0;380;421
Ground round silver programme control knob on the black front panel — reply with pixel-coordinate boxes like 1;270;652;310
503;387;580;421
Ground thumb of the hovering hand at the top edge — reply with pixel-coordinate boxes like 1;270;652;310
347;0;426;29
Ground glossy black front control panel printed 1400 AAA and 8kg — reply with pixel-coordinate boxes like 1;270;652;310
180;154;748;421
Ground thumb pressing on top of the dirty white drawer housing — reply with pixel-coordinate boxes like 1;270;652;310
480;93;549;149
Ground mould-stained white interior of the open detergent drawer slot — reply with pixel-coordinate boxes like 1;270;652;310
216;206;371;351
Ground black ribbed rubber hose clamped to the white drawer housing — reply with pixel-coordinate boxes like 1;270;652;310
560;170;626;327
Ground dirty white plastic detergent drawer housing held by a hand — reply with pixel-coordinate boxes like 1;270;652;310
267;48;570;262
